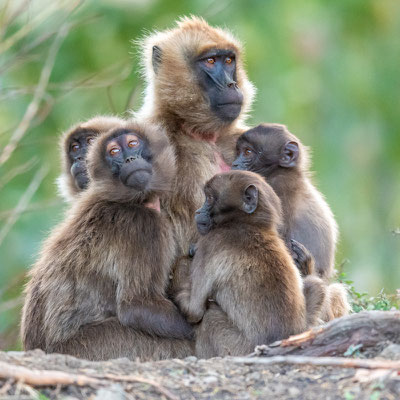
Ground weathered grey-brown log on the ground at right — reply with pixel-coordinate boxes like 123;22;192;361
247;311;400;357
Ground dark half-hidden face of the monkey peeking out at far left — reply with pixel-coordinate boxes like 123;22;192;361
68;130;98;190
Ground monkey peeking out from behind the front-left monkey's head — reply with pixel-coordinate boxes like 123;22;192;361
57;115;124;201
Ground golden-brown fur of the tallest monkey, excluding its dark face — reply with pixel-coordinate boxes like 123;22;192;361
134;17;254;257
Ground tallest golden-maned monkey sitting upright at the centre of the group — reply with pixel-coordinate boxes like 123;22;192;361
138;17;254;257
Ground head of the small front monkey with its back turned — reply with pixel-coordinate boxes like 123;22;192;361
195;171;281;235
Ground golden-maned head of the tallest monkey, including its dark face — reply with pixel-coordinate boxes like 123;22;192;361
139;17;254;133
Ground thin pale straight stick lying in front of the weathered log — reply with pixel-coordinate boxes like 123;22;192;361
229;356;400;371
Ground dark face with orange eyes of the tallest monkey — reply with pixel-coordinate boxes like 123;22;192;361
195;49;243;122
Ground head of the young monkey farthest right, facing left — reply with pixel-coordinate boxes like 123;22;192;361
232;124;308;178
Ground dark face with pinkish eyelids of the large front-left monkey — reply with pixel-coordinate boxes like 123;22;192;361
105;130;152;191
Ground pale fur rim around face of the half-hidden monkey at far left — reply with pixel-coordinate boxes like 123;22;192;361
57;115;124;201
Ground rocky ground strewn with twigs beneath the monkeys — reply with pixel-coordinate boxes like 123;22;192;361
0;313;400;400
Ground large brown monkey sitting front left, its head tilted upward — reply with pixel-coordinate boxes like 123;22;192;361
22;121;192;360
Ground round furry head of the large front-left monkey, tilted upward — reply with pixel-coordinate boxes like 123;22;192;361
88;121;175;203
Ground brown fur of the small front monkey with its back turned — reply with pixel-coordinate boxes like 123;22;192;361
180;171;307;357
